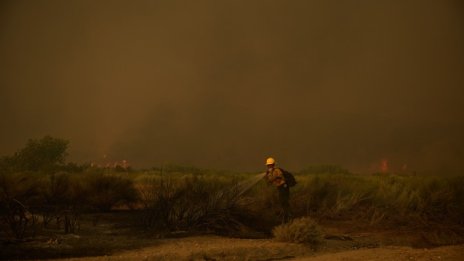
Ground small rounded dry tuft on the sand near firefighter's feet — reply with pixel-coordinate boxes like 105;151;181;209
272;217;322;246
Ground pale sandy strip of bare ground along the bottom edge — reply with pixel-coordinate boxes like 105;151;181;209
55;236;464;261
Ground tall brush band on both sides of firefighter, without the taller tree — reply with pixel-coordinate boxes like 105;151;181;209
0;166;464;240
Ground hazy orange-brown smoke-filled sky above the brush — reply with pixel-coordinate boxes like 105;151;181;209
0;0;464;172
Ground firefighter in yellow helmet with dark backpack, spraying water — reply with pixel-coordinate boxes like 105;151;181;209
265;158;290;223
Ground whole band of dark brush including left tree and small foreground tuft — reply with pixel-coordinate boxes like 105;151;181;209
0;136;464;258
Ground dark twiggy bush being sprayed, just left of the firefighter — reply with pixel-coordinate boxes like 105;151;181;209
139;176;245;233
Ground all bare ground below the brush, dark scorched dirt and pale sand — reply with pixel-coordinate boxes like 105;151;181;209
0;213;464;261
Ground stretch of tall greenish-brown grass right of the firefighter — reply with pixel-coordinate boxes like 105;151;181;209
292;174;464;225
